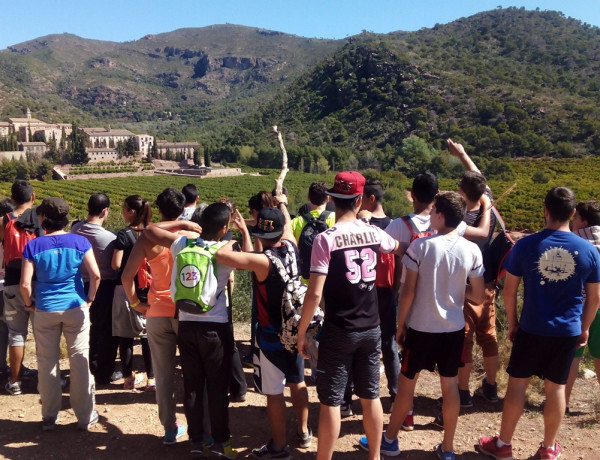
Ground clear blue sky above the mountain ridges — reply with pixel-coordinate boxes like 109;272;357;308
0;0;600;49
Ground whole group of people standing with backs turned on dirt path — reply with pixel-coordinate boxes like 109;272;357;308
0;139;600;460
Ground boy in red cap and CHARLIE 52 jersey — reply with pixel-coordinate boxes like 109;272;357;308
298;171;398;460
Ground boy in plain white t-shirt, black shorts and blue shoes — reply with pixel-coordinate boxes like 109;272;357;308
360;192;484;460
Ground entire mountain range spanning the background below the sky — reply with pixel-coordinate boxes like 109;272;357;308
0;7;600;165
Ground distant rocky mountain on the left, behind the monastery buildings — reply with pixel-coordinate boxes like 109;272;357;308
0;24;340;128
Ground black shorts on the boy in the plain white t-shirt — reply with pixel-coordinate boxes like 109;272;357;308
400;328;465;379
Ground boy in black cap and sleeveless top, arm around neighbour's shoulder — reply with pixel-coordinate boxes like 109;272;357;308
215;201;312;459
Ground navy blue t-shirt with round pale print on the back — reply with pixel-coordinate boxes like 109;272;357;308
504;229;600;337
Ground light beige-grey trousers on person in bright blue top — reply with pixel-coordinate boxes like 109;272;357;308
33;304;95;424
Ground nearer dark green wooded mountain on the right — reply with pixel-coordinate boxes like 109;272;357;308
244;8;600;169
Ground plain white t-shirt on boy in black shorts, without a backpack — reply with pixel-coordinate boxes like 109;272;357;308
402;235;484;332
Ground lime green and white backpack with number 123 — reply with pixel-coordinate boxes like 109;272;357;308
173;238;225;313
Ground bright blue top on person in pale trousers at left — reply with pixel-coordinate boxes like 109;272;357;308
23;233;92;312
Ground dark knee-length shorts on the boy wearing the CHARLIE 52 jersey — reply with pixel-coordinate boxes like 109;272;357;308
317;323;381;407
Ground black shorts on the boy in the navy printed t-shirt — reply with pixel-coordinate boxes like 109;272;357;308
506;329;579;385
